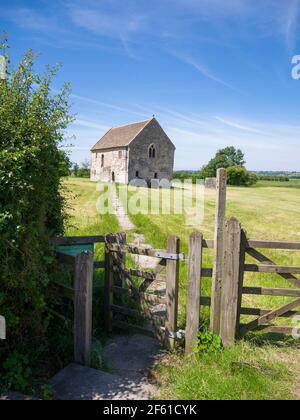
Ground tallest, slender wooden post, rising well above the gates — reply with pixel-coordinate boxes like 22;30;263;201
210;168;227;335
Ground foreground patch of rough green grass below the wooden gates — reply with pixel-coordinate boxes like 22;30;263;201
155;342;291;400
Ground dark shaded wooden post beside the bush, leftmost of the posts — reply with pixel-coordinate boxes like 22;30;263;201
74;252;93;366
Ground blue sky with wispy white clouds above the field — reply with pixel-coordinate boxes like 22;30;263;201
0;0;300;170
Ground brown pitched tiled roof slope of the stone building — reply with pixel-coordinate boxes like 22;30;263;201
92;119;152;150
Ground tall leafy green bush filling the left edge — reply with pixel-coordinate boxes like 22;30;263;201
0;40;71;369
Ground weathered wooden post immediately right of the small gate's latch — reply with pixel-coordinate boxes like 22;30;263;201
185;232;203;353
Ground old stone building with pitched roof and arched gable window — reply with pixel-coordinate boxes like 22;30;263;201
91;117;175;184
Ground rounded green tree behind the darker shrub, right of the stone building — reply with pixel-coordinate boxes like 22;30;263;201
200;146;246;178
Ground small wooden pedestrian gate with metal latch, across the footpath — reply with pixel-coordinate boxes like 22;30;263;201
104;234;183;348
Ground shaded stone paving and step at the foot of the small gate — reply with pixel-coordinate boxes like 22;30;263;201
50;334;161;400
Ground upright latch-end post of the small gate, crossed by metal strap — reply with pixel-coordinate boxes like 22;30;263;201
165;236;180;349
